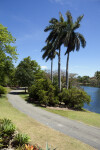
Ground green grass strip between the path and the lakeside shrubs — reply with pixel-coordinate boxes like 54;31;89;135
20;94;100;127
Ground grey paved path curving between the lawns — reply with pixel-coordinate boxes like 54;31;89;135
7;90;100;150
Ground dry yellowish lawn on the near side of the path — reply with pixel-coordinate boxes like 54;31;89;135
0;96;94;150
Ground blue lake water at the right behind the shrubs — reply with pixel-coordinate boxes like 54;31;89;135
82;86;100;114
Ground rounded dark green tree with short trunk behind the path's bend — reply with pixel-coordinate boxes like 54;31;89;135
15;57;41;93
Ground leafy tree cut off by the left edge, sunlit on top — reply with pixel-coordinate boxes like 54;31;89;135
0;24;17;86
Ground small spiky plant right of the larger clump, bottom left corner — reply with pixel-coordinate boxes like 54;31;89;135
13;133;30;146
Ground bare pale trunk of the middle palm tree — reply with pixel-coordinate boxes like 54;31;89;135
58;48;61;92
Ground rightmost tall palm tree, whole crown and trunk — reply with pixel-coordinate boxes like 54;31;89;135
62;11;86;89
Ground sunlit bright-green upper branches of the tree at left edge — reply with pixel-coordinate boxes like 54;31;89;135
0;24;17;59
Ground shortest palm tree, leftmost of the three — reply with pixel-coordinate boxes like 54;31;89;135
41;43;57;83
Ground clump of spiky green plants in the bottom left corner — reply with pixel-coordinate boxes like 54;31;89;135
0;118;30;148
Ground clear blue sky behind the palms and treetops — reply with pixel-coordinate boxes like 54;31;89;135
0;0;100;77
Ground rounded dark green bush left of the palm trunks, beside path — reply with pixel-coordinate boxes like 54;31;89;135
29;78;57;106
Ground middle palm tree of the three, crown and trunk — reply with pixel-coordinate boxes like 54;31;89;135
44;13;64;91
